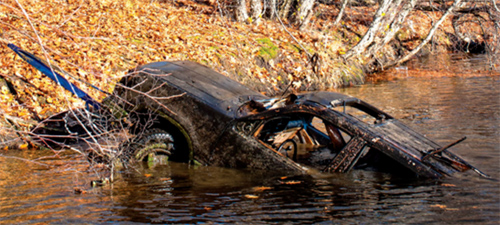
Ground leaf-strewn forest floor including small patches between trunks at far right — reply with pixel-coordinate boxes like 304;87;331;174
0;0;499;148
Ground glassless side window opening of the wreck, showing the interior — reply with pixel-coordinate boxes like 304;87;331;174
249;113;351;170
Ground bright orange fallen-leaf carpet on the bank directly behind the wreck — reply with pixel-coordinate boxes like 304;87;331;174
0;0;360;125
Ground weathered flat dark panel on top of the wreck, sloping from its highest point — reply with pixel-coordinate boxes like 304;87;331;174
136;61;268;117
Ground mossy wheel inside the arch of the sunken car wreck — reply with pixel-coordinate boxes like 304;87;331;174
125;128;175;165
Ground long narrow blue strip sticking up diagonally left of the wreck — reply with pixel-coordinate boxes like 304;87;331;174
7;44;100;109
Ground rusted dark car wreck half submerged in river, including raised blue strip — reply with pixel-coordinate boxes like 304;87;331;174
9;45;487;178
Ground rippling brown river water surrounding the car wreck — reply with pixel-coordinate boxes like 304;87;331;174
0;54;500;224
